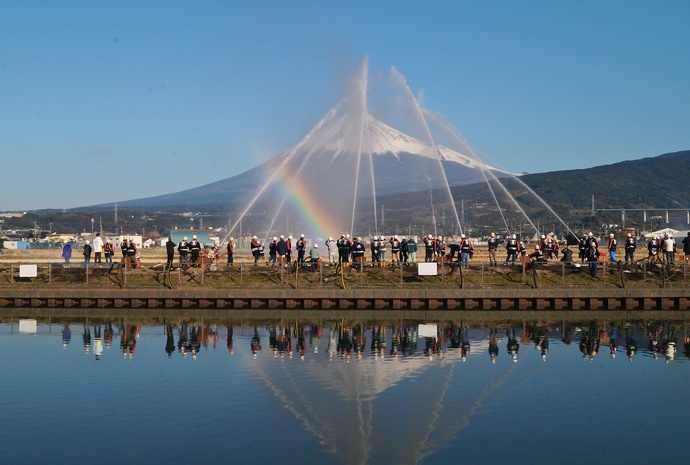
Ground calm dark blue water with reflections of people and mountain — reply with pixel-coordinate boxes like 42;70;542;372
0;318;690;464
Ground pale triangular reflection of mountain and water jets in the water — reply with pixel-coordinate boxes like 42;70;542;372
247;326;524;464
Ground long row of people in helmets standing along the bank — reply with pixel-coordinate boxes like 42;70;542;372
62;232;690;276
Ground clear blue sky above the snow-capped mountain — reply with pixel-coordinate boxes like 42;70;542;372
0;0;690;210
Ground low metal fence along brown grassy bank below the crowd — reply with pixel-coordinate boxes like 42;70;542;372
0;260;688;289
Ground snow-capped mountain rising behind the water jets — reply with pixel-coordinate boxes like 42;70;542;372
106;109;513;208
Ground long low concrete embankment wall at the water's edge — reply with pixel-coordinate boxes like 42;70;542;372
0;288;690;317
